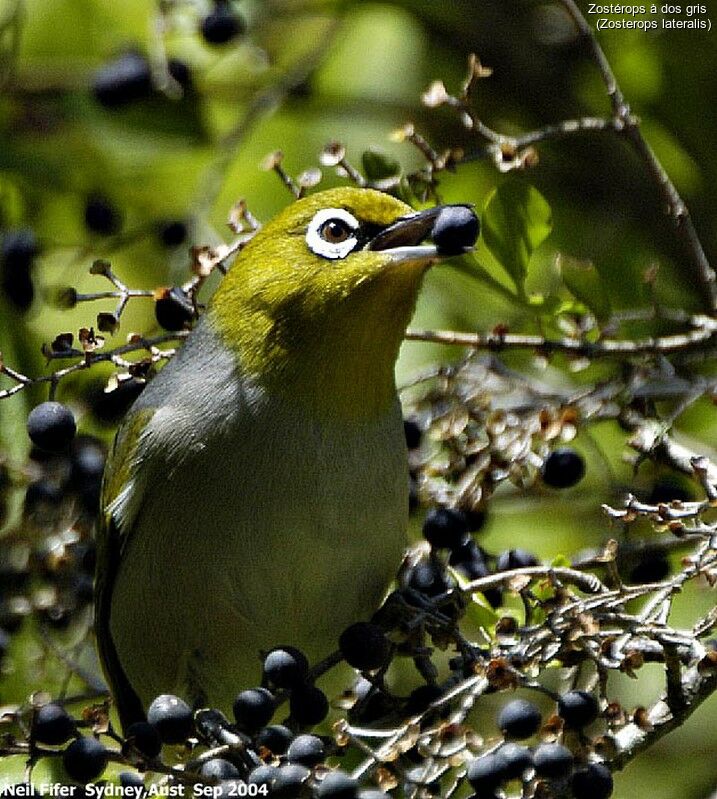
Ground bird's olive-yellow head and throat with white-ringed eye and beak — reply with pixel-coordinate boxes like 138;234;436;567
209;187;478;418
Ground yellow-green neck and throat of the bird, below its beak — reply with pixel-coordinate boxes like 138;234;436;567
210;274;418;421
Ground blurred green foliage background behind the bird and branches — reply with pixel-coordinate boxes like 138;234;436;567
0;0;717;799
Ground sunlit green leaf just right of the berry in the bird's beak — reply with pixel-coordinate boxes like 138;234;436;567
481;180;553;295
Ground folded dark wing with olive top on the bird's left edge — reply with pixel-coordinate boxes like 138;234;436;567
95;407;159;730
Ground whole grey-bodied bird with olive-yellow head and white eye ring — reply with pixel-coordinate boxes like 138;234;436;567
96;188;477;727
